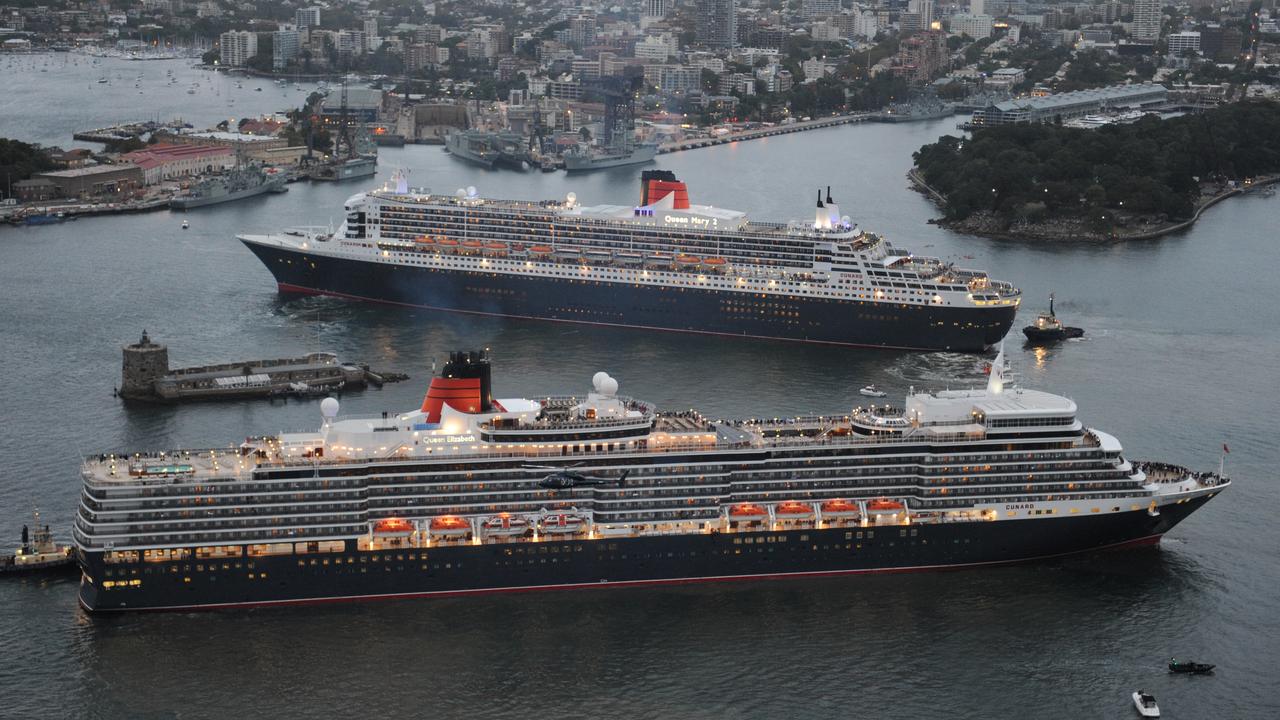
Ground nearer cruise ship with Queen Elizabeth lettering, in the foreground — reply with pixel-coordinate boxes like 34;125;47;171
74;352;1230;611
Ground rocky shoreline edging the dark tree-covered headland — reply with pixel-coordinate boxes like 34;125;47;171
906;168;1280;242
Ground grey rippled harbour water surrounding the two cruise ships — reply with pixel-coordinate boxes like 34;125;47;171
0;63;1280;719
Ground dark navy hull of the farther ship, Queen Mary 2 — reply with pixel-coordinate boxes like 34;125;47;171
244;241;1016;352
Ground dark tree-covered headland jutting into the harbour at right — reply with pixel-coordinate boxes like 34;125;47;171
909;101;1280;241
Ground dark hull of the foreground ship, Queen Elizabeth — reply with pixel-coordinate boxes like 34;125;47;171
79;496;1210;611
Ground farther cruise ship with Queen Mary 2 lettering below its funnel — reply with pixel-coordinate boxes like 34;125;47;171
239;170;1021;351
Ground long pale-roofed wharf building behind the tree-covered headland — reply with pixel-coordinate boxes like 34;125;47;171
972;82;1169;127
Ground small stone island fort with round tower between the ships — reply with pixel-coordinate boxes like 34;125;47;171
115;331;408;402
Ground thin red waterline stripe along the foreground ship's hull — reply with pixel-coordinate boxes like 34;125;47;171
81;534;1162;612
